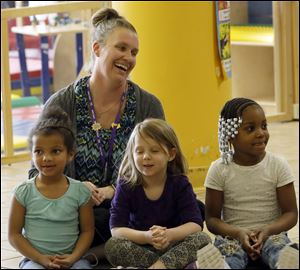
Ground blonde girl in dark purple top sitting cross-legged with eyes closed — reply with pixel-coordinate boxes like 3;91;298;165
105;119;211;269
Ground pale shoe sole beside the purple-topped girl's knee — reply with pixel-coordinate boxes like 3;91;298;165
197;243;228;269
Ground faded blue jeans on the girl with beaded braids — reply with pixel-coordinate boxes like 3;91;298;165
214;232;291;269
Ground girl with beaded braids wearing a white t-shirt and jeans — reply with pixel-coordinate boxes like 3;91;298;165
198;98;299;269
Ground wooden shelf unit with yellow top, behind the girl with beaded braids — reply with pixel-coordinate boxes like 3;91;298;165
230;26;277;115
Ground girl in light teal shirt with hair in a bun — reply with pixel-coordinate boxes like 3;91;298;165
8;107;94;269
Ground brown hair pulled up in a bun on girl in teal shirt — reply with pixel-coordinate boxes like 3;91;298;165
28;106;75;152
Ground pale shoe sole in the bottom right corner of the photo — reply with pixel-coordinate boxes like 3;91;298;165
277;245;299;269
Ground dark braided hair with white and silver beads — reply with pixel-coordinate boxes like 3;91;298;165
218;98;261;164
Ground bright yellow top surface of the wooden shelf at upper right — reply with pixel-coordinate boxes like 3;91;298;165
230;26;274;47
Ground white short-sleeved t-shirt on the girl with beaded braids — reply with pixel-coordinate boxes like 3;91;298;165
204;152;294;229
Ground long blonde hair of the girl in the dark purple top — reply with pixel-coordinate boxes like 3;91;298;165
118;118;187;186
